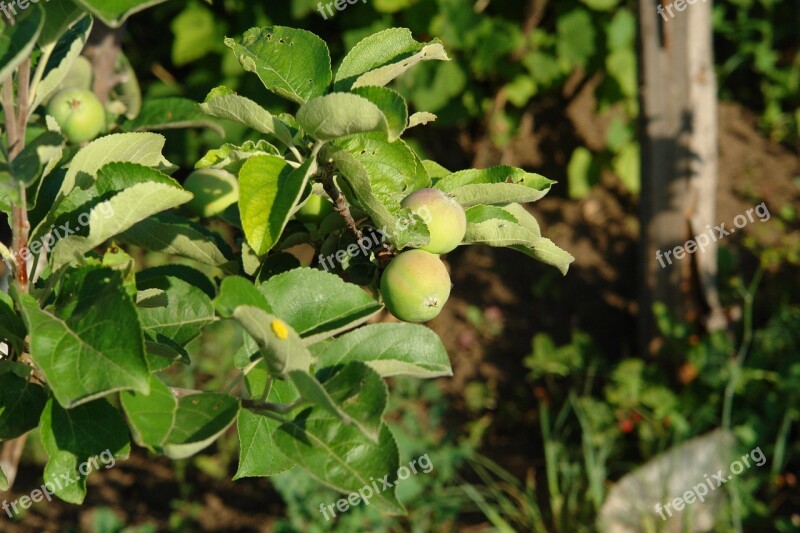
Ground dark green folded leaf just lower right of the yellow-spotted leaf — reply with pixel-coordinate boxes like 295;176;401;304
289;362;388;443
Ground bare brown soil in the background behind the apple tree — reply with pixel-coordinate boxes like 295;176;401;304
0;98;800;533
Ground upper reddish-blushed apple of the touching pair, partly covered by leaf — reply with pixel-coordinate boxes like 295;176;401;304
400;189;467;254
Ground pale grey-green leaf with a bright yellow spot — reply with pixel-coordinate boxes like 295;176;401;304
233;305;311;376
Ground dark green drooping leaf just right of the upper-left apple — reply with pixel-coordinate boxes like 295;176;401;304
123;97;225;136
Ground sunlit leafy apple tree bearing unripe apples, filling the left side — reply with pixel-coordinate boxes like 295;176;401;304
0;1;572;513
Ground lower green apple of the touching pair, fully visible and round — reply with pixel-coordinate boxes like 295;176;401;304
381;250;450;322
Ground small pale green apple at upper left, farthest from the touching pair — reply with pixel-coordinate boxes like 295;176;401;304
47;87;106;143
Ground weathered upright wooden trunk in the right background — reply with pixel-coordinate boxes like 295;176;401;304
639;0;725;354
